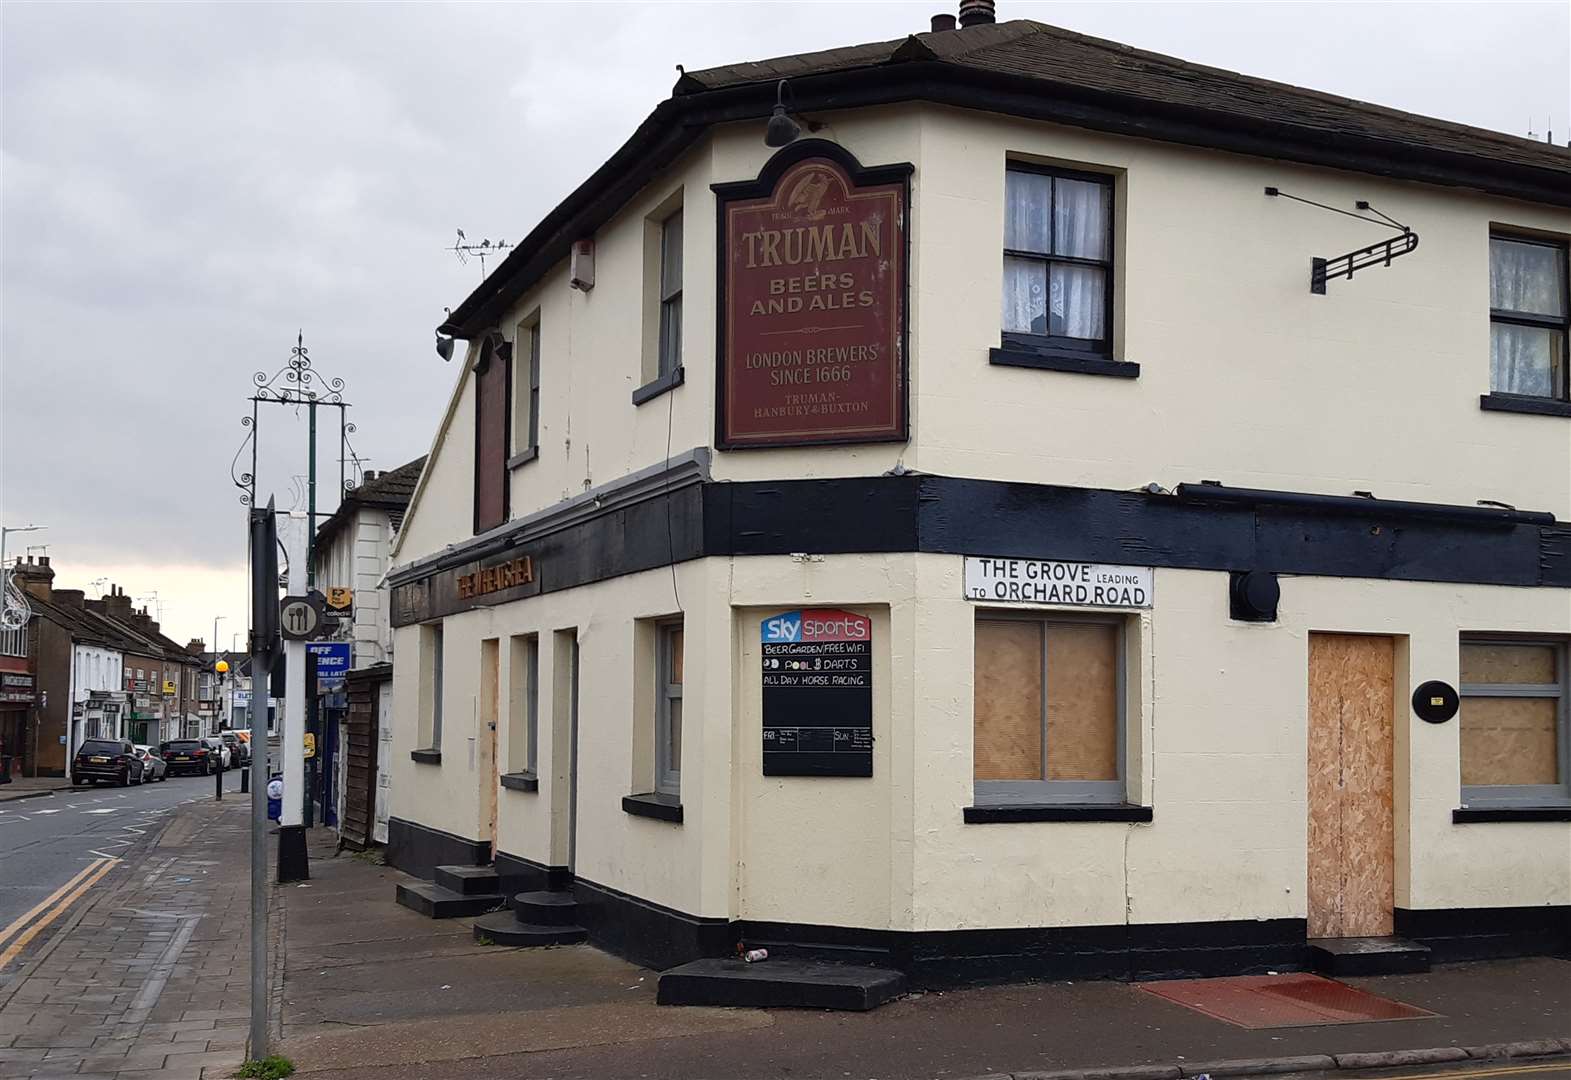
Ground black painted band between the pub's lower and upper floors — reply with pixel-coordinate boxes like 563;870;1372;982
390;477;1571;626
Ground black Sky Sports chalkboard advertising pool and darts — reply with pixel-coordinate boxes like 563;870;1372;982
759;608;873;777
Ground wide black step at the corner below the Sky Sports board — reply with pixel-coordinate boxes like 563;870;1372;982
655;959;905;1012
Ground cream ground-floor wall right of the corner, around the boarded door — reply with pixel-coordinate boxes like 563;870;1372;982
914;555;1571;929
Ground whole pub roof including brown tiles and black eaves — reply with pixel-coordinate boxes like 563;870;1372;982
438;19;1571;340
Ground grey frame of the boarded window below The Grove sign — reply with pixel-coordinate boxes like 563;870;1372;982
971;607;1130;806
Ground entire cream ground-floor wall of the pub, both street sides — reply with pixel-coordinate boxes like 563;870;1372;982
393;555;1571;929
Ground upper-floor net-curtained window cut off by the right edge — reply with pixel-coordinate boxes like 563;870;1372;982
1489;236;1571;401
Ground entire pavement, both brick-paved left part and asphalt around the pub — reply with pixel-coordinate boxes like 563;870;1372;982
0;799;1571;1080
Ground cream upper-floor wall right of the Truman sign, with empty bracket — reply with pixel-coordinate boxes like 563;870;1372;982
906;108;1571;517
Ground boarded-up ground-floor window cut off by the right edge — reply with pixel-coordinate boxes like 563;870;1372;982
1459;640;1571;802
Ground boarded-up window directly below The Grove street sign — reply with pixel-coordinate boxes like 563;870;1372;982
972;618;1123;802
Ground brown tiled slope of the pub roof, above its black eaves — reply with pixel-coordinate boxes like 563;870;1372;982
679;19;1571;175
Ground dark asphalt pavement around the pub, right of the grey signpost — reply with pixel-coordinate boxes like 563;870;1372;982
283;838;1571;1080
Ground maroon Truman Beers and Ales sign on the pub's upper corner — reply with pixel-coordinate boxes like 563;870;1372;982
715;140;911;450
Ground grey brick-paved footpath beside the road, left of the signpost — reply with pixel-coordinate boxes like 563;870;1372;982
0;799;281;1080
